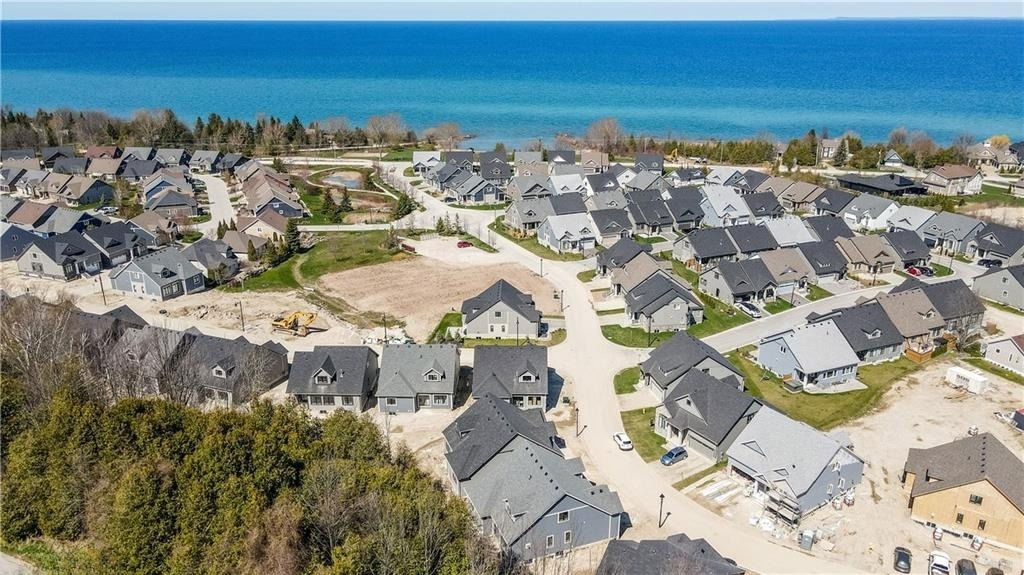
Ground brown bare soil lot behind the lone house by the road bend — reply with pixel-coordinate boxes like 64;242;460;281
317;257;558;342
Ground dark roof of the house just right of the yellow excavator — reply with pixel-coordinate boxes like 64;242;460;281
288;346;377;397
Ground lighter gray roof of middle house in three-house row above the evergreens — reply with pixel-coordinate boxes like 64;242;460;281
377;344;459;397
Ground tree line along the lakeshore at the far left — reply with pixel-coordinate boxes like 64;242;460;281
0;106;417;154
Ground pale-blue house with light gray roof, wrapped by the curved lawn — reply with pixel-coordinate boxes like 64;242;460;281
758;319;860;390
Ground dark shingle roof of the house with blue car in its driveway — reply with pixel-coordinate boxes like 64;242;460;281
665;369;760;446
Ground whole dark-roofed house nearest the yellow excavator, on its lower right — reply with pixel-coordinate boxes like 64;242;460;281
286;346;378;415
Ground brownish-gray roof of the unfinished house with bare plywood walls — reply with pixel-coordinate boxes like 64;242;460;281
903;433;1024;513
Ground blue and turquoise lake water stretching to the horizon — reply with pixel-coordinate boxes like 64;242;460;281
0;20;1024;147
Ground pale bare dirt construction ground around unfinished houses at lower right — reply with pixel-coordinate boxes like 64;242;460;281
688;359;1024;573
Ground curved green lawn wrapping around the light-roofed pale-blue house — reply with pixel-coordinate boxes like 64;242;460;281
727;346;921;430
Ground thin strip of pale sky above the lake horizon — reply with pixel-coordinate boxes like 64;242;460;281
8;0;1024;20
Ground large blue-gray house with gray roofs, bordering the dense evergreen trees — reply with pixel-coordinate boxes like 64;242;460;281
443;396;624;561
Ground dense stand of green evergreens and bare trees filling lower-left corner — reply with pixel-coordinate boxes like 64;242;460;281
0;300;519;575
